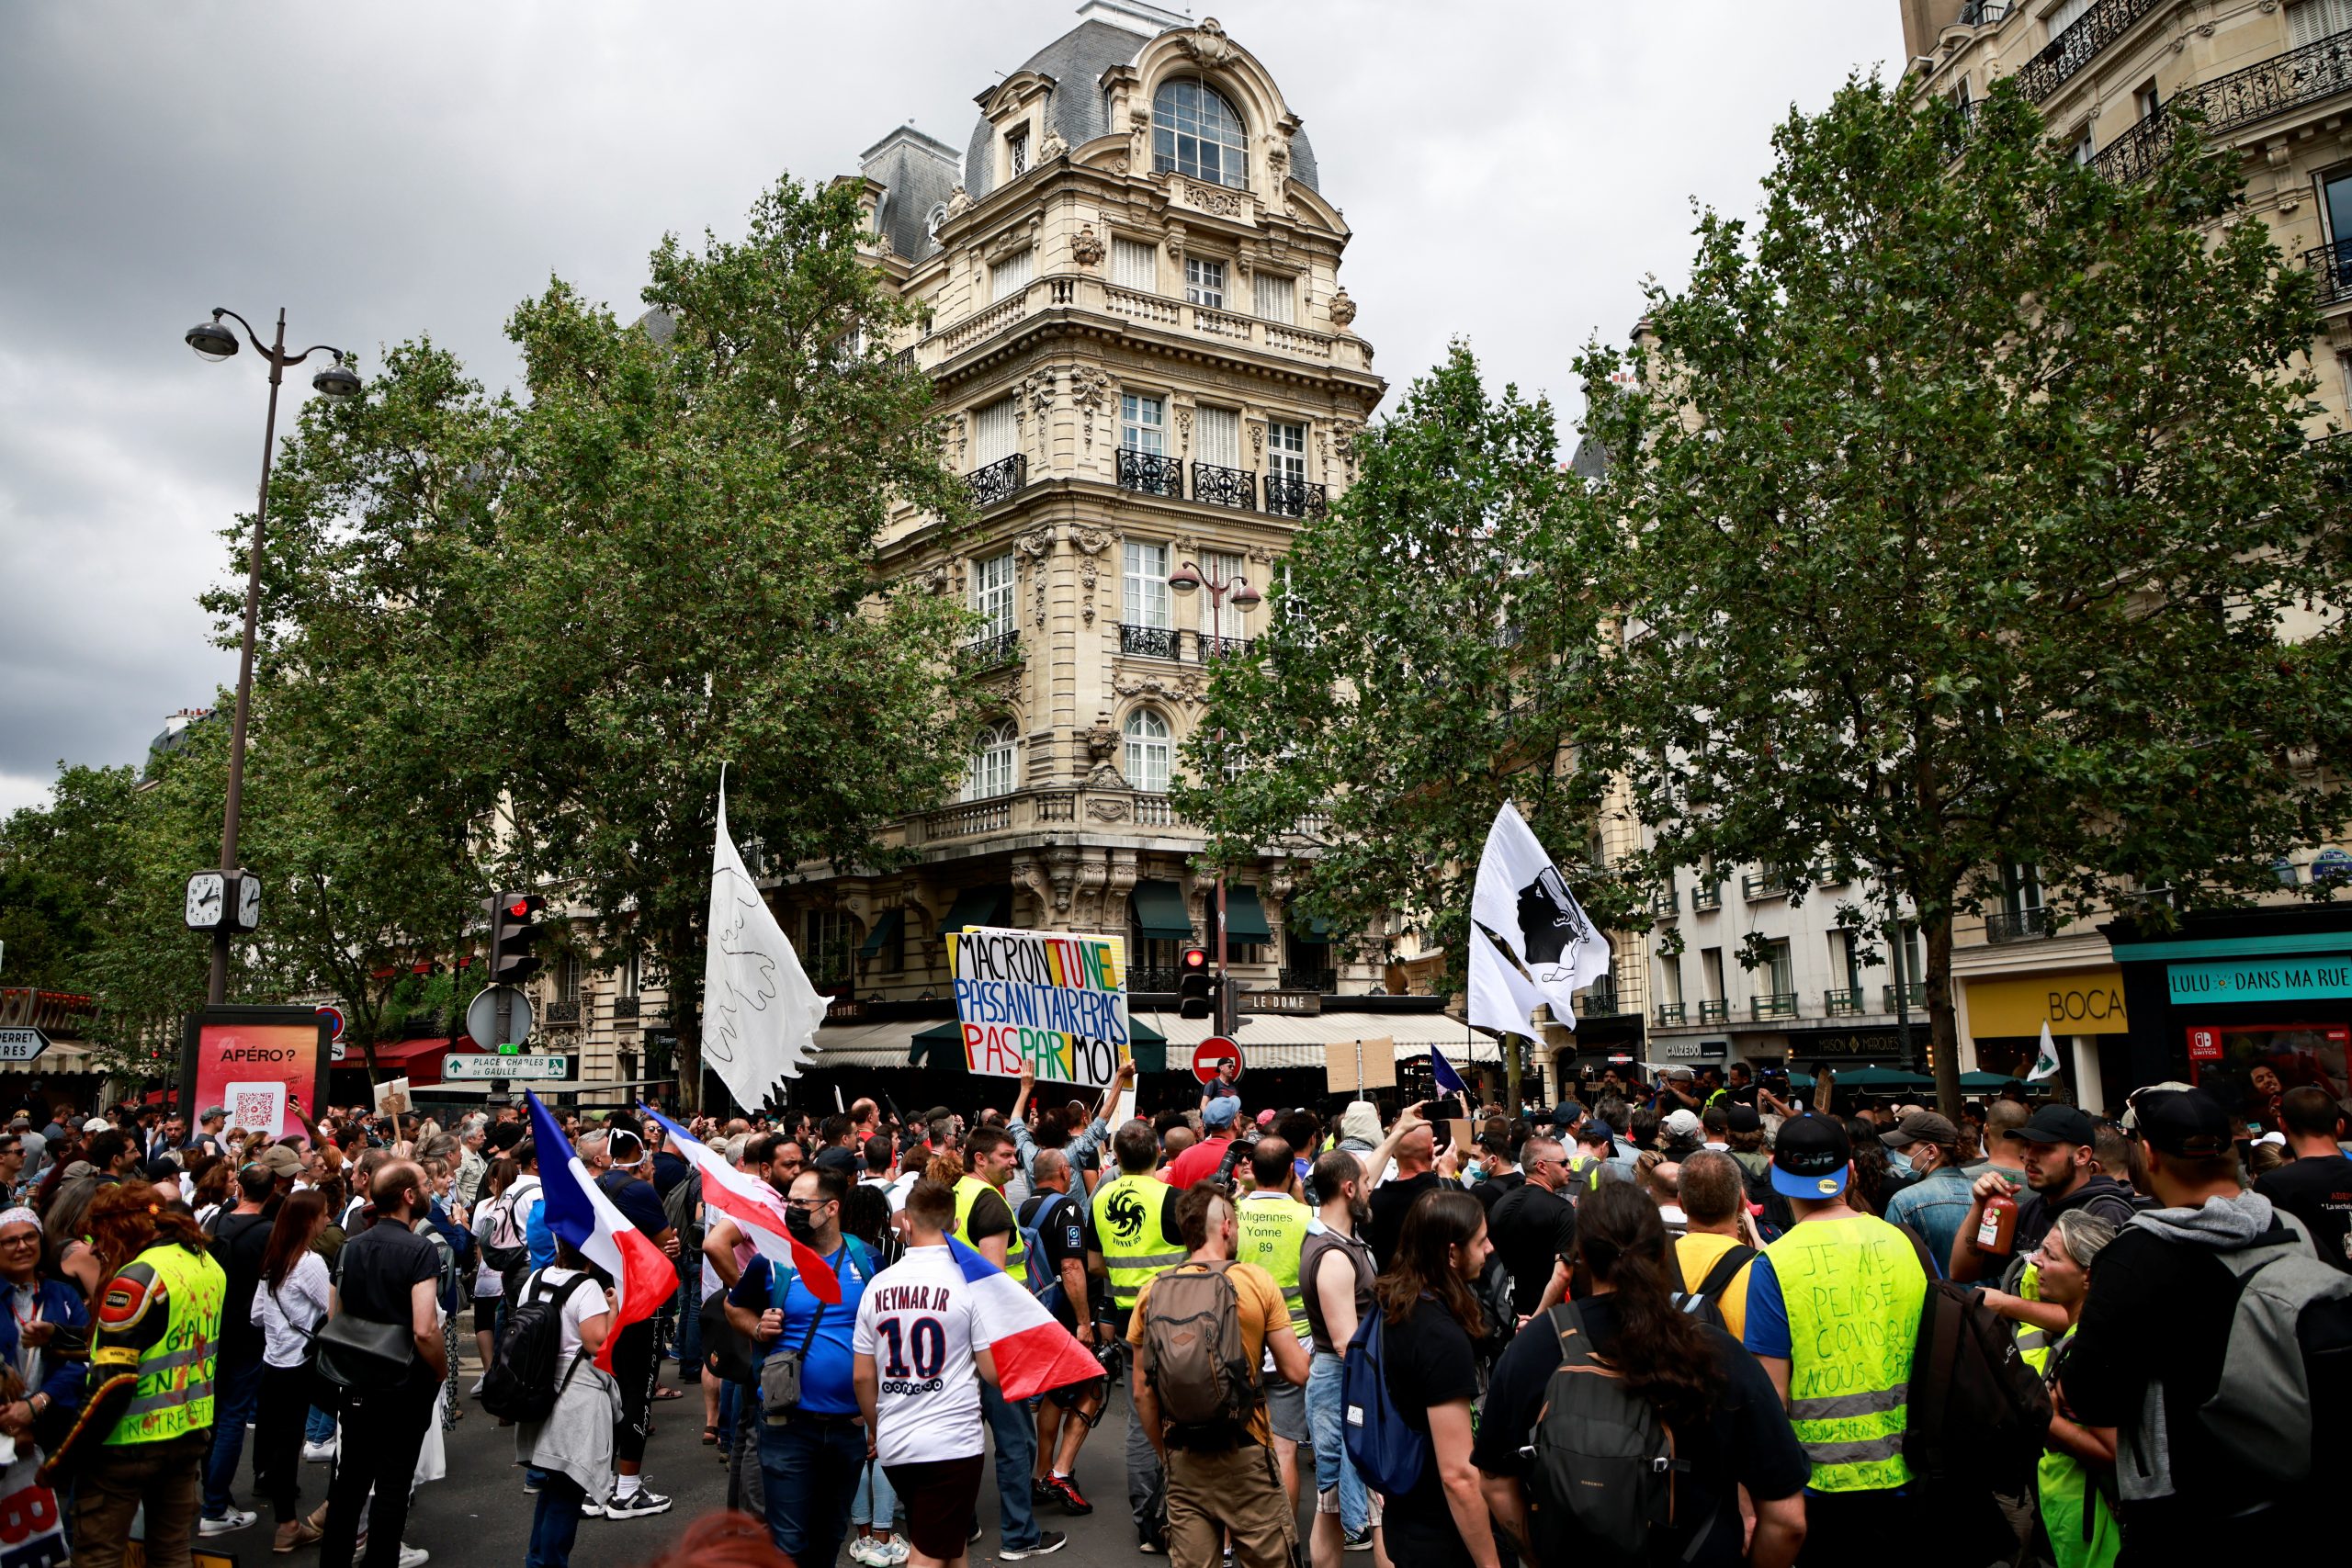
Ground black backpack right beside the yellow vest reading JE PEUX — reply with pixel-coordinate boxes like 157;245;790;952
1895;1227;2051;1497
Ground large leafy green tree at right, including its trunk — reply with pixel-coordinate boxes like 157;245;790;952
1580;80;2352;1105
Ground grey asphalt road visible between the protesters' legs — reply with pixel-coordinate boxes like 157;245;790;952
200;1337;1326;1568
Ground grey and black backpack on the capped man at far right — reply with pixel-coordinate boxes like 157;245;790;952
2204;1229;2352;1485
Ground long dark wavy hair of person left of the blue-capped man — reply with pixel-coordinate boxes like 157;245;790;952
1580;1182;1724;1425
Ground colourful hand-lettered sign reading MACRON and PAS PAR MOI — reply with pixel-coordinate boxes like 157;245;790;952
948;926;1131;1089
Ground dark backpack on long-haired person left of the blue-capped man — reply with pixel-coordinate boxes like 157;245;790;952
1521;1303;1722;1568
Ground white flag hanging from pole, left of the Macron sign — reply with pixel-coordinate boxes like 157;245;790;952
703;769;826;1110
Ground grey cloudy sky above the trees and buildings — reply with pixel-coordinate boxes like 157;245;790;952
0;0;1903;811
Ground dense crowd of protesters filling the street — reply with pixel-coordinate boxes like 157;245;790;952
0;1048;2352;1568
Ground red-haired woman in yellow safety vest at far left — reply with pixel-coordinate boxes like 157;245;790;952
42;1182;228;1568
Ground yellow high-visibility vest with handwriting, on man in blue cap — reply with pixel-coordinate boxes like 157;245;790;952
1764;1215;1927;1493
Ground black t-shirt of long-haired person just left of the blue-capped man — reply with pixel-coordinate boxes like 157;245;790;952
1470;1295;1814;1568
